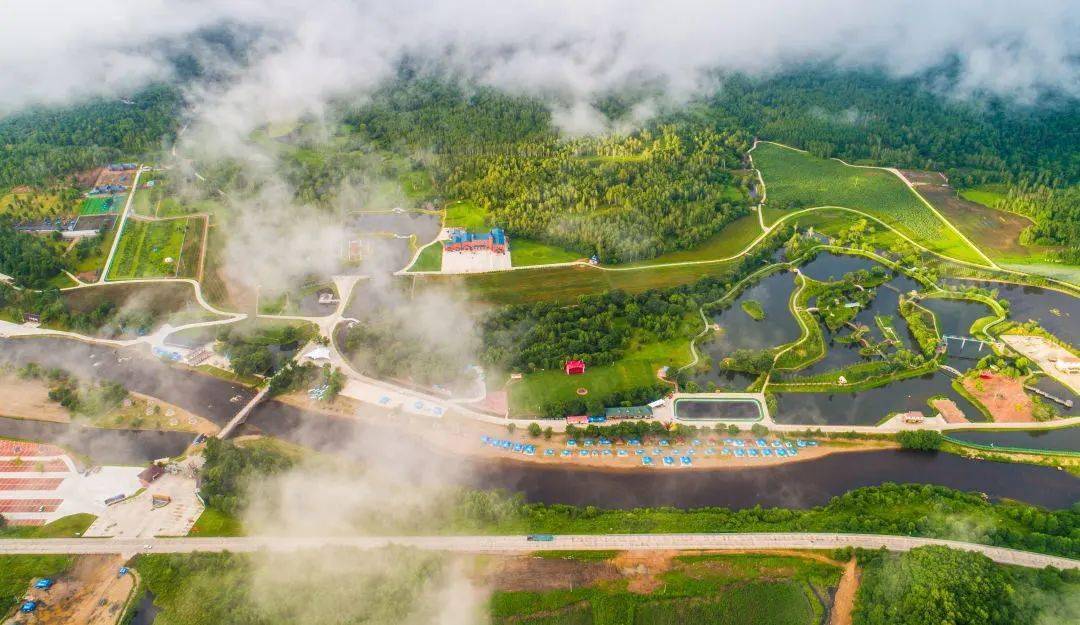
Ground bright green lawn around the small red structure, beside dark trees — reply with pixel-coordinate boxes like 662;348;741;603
507;338;692;417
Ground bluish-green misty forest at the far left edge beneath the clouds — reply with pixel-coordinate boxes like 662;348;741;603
0;84;180;189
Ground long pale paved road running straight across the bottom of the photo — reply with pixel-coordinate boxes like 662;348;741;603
0;533;1080;569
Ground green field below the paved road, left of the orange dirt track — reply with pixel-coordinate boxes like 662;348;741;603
490;555;839;625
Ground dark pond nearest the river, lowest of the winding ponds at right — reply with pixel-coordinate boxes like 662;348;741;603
772;371;983;425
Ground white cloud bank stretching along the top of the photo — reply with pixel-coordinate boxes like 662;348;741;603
0;0;1080;127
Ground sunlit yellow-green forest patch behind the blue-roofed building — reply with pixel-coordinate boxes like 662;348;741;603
447;125;750;262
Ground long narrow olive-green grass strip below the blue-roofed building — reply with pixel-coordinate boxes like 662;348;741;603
411;261;733;304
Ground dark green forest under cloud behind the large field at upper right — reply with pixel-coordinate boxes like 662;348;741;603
701;67;1080;187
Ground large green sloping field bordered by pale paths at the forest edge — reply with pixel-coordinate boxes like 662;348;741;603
753;142;986;264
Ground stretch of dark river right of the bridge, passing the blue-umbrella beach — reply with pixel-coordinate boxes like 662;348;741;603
238;402;1080;507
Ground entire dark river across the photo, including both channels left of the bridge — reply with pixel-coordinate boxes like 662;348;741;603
0;330;1080;507
